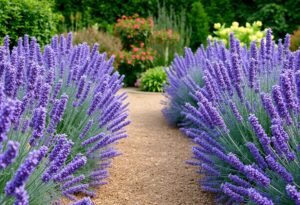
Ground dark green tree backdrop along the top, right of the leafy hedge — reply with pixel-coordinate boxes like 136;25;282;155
55;0;300;48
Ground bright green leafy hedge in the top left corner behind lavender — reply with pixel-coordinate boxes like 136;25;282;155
0;0;59;45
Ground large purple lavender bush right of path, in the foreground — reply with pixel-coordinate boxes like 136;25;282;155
164;30;300;205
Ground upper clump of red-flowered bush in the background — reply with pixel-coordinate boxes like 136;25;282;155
115;15;153;50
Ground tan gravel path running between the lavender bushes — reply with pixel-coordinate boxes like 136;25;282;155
94;89;213;205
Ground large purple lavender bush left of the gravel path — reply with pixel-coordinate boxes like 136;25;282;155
0;34;129;205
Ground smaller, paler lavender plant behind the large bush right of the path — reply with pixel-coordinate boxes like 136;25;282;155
162;48;203;126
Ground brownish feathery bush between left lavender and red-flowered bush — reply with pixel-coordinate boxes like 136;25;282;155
73;27;122;55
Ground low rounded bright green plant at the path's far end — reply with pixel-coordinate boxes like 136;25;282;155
140;67;167;92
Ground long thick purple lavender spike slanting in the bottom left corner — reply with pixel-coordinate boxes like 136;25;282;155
5;146;48;195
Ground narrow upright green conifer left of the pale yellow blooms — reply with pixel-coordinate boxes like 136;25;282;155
188;2;208;48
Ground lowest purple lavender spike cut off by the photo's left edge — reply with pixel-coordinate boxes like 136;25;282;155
0;141;20;170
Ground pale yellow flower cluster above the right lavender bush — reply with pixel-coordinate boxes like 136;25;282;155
209;21;265;46
